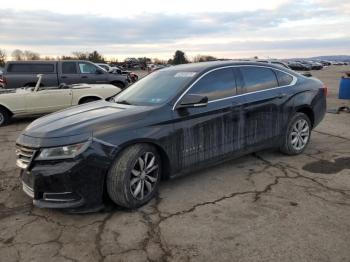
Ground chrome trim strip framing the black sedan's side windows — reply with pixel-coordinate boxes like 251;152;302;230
172;65;298;111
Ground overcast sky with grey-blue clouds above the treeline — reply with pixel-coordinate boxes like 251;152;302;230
0;0;350;59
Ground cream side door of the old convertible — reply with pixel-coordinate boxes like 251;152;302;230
26;89;72;114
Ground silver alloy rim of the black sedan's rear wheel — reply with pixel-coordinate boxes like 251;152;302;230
289;119;310;151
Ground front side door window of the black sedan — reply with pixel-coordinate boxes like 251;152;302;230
190;68;236;101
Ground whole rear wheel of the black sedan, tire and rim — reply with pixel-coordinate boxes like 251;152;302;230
280;113;312;155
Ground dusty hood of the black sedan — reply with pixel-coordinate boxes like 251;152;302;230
23;101;152;138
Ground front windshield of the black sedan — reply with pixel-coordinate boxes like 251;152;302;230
113;70;196;105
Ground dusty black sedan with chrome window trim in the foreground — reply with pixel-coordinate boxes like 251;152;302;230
16;61;326;212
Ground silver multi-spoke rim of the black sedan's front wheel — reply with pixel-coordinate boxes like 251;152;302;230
130;152;159;200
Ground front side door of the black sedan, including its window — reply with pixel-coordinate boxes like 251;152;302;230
173;68;245;168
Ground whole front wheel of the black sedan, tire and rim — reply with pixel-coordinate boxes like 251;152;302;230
106;144;162;209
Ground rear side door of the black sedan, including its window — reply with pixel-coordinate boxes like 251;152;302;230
239;66;285;148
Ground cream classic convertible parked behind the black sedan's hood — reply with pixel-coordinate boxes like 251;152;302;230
0;75;121;127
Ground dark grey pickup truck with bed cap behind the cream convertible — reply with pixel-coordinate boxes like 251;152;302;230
2;60;130;89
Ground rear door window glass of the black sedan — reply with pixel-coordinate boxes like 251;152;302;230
240;66;278;93
